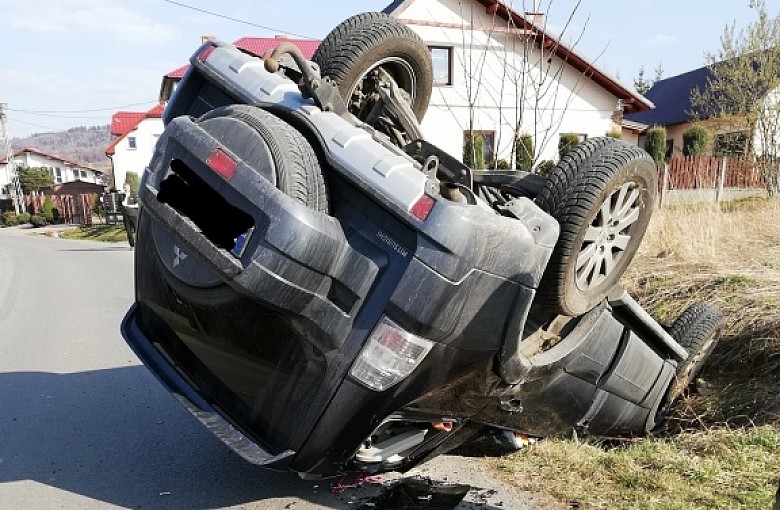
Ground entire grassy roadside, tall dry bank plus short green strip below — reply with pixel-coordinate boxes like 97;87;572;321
496;200;780;510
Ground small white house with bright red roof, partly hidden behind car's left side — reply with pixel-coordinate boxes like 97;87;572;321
106;104;164;191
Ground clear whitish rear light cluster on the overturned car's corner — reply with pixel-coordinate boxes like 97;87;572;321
349;316;433;391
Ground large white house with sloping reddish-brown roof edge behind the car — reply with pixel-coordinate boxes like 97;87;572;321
384;0;653;165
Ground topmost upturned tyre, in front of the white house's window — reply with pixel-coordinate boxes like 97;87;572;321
312;12;433;121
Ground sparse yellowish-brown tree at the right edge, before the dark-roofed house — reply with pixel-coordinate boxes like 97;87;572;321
691;0;780;195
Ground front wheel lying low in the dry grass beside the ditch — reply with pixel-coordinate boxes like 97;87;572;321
666;302;723;403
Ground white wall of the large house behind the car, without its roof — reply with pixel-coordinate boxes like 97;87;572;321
396;0;617;164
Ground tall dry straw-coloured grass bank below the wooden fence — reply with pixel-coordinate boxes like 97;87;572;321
623;200;780;428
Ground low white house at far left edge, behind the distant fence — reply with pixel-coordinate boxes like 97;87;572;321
0;148;103;198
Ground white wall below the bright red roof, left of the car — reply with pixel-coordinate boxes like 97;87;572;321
111;118;163;191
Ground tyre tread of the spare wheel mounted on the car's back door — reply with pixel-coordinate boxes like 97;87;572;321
197;105;329;213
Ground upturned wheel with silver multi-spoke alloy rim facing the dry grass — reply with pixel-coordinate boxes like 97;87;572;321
536;138;658;316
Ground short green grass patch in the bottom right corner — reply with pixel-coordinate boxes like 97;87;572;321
496;426;780;510
